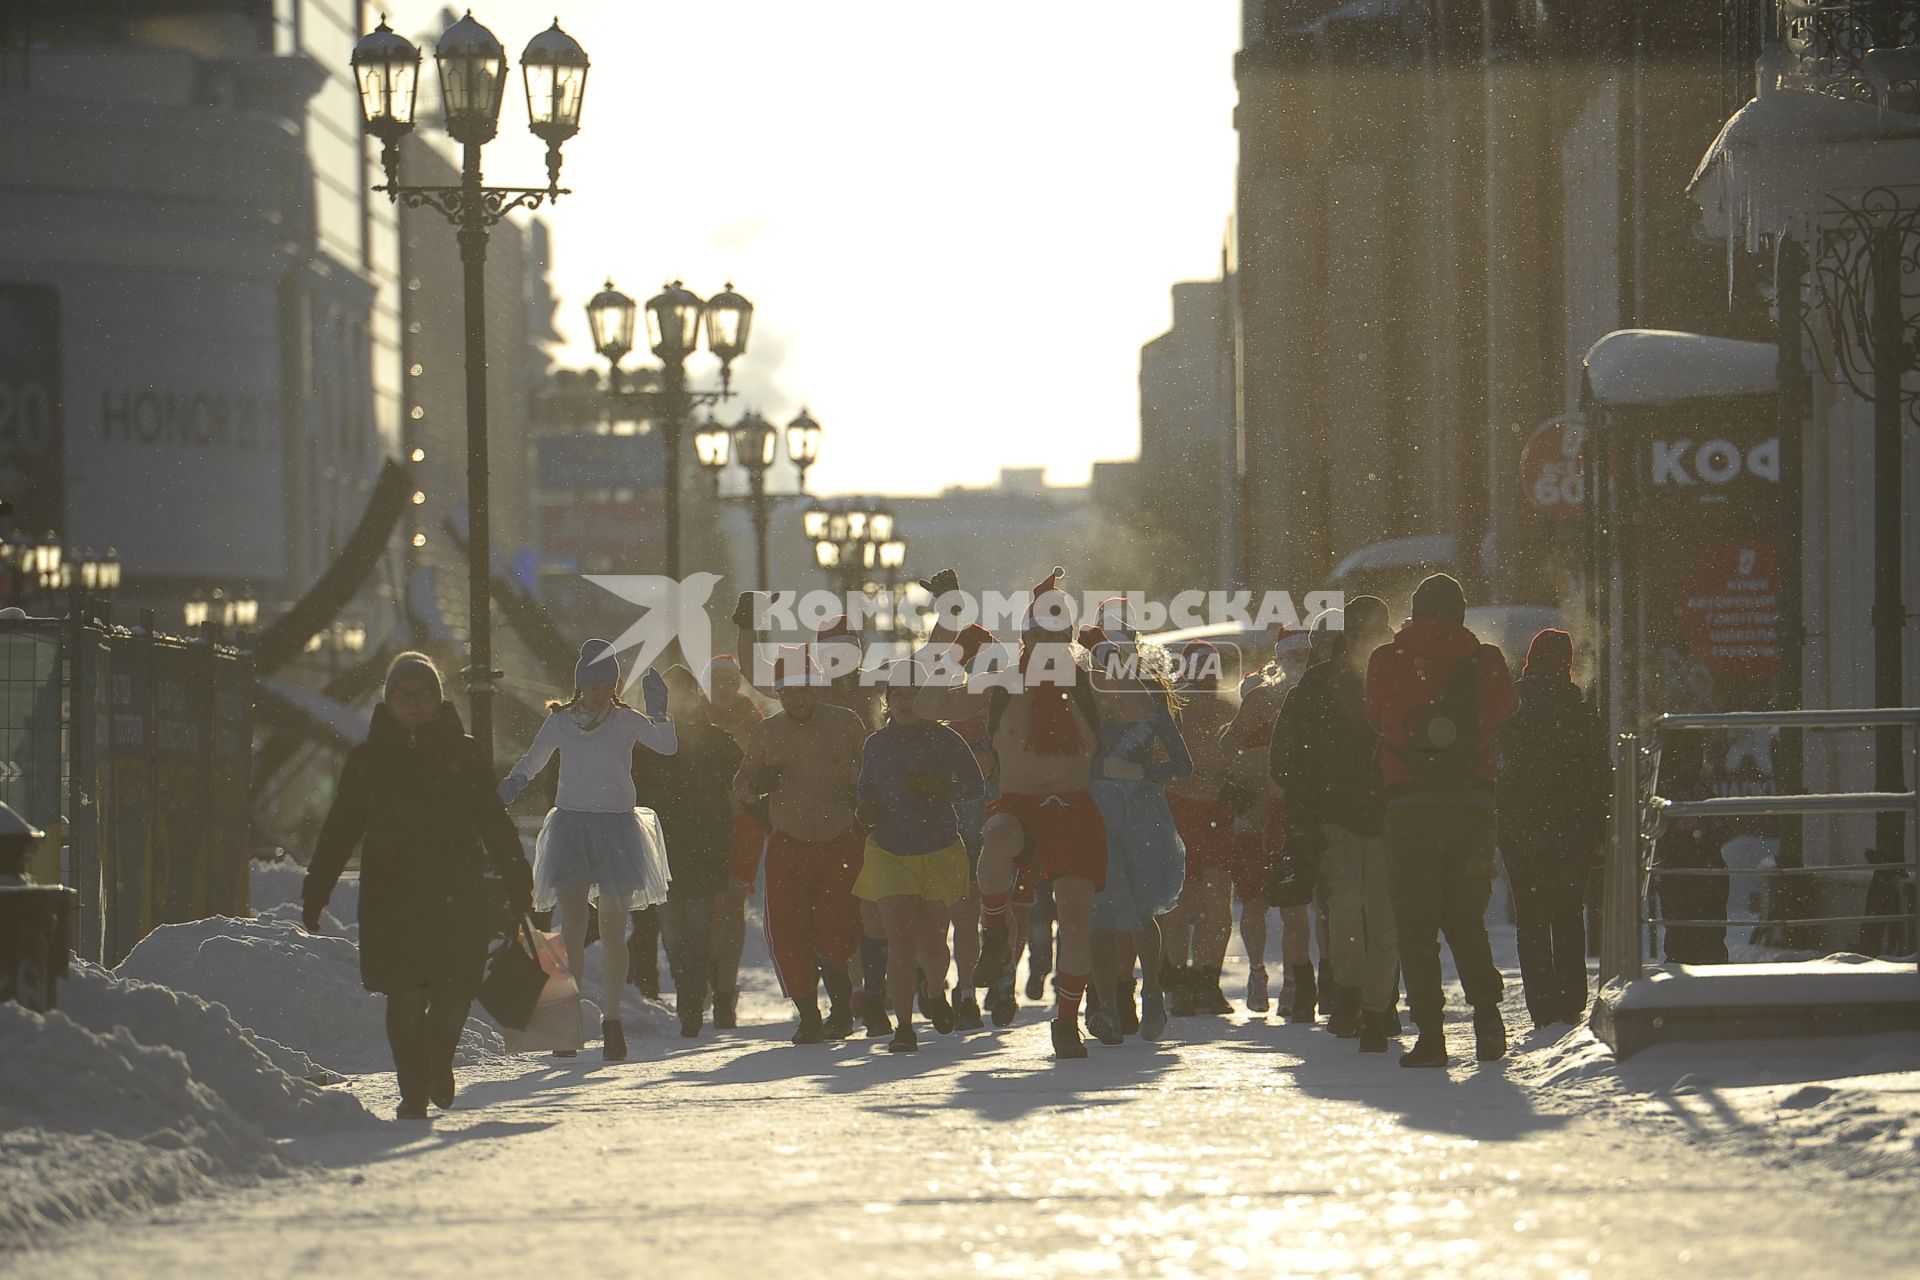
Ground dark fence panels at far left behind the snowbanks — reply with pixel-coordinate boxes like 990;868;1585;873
0;618;253;963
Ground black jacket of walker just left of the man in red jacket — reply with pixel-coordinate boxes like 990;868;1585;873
1267;652;1384;835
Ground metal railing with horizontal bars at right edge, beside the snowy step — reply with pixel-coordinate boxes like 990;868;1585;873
1599;708;1920;981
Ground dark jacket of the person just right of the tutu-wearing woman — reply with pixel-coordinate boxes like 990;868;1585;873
634;716;741;896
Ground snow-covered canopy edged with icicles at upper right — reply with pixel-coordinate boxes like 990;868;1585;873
1688;88;1920;251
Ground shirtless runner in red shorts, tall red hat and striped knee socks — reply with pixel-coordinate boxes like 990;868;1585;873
920;568;1106;1057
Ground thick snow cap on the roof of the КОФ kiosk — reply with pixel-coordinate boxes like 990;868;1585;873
1586;328;1780;407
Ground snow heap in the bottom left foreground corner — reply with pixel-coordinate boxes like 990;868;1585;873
0;1004;282;1240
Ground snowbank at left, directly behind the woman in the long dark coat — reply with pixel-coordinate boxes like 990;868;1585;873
115;906;503;1075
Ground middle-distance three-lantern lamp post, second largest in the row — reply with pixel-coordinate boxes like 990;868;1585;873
588;280;753;578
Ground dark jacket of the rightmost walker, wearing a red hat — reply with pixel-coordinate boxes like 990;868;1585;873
1496;676;1613;864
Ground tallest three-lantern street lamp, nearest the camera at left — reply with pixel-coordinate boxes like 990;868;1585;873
351;13;588;760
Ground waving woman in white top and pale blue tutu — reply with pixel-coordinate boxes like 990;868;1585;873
499;639;680;1061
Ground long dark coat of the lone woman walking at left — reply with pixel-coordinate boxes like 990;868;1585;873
301;702;534;998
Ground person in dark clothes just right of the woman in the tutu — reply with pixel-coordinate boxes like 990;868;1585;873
634;666;741;1036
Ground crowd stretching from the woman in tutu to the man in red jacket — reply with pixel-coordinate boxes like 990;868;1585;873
307;568;1543;1098
